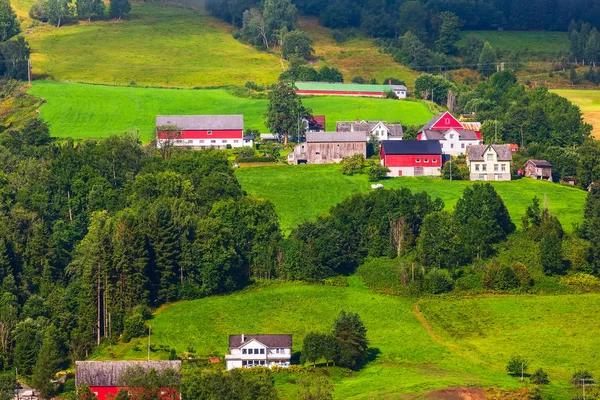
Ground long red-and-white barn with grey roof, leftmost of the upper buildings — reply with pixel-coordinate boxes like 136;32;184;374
156;115;254;150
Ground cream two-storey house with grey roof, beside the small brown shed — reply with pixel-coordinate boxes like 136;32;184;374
467;144;512;181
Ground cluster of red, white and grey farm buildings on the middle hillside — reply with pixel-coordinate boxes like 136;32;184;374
156;111;552;181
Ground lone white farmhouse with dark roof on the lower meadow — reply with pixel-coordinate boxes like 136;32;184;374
225;334;292;370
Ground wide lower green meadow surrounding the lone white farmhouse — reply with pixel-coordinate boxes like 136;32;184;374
93;277;600;399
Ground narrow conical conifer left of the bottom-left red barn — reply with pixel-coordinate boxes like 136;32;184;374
33;325;64;399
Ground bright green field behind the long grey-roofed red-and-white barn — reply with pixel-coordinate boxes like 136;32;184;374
29;81;432;142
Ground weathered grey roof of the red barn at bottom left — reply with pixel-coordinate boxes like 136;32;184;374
75;361;181;386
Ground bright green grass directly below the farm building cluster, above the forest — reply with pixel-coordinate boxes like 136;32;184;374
236;165;586;232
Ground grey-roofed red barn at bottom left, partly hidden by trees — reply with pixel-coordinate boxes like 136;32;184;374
75;361;181;400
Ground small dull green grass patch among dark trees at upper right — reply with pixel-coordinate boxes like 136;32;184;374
461;31;569;59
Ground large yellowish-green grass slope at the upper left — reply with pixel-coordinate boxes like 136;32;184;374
27;4;282;87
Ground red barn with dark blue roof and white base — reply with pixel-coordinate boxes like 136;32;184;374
380;140;442;176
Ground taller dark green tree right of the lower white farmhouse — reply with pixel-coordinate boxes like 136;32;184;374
333;310;369;368
